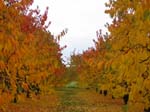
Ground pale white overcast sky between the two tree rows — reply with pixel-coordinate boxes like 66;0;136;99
33;0;110;60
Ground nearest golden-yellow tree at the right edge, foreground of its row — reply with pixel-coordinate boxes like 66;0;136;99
106;0;150;109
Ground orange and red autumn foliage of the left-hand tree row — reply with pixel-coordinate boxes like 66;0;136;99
0;0;65;105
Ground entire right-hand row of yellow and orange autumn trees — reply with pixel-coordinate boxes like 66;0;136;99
71;0;150;112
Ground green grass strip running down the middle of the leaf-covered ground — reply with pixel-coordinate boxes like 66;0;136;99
57;88;86;112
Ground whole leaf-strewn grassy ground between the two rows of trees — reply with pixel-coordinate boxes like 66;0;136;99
0;88;124;112
